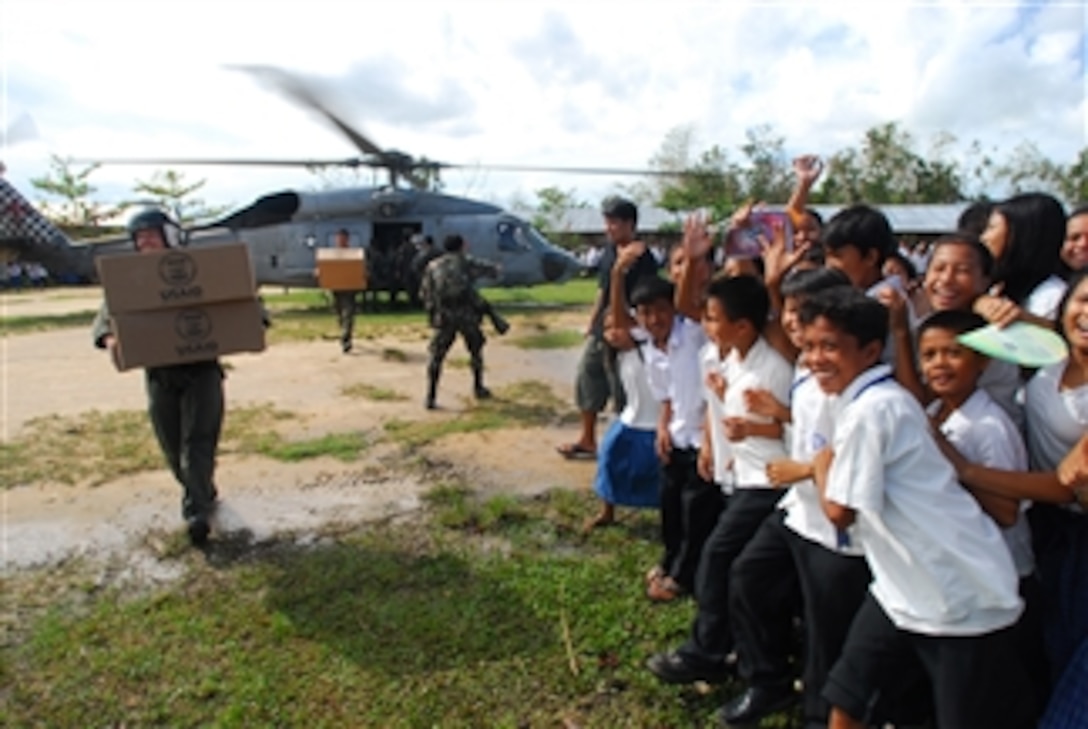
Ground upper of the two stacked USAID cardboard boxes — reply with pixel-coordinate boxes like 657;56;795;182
95;243;256;314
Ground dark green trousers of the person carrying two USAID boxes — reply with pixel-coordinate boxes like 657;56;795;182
146;361;223;519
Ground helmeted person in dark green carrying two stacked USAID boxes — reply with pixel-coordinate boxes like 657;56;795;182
94;210;223;546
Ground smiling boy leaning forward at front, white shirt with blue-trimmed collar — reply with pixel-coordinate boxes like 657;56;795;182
801;288;1031;729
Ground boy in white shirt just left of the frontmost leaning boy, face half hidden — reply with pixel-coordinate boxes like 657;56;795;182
721;269;871;726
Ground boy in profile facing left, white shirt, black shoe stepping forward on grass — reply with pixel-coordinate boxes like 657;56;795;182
647;276;793;683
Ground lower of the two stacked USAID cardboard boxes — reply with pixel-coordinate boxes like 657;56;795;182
112;299;264;370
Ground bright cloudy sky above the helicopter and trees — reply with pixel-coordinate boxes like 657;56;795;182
0;0;1088;214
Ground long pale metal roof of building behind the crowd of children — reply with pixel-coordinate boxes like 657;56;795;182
556;202;968;235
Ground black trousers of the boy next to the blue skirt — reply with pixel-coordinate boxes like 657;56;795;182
662;448;724;593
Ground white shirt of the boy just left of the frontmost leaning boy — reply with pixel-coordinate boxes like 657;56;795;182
778;366;864;557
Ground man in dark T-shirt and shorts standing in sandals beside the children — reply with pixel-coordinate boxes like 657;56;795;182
557;197;657;460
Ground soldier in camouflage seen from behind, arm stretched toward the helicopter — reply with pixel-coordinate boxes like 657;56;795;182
419;235;498;410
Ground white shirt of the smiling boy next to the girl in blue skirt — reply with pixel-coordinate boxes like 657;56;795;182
642;314;706;448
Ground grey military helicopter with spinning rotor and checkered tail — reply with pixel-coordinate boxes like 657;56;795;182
0;66;665;296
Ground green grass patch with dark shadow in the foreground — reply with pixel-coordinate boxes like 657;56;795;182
0;493;789;728
